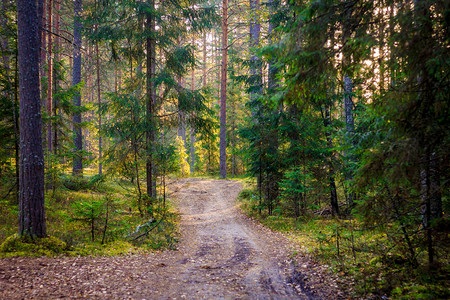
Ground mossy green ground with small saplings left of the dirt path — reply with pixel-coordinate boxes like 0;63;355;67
0;176;178;257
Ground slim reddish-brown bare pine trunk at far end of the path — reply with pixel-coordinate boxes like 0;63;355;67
219;0;228;178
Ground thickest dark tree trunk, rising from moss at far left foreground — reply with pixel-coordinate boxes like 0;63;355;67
17;0;47;237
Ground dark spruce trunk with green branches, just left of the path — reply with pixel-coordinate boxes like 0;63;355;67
146;0;156;197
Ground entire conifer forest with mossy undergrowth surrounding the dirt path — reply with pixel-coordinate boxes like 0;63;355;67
0;0;450;299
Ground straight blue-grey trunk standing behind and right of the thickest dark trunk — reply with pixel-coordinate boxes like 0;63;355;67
72;0;83;176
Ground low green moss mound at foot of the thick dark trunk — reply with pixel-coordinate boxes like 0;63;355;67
0;234;67;257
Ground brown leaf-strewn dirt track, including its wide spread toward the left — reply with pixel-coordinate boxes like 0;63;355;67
0;178;342;299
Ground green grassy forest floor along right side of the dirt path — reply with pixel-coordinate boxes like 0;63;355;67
239;184;450;299
